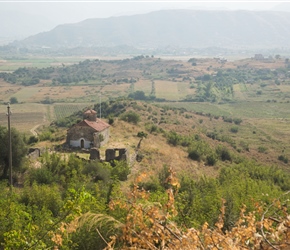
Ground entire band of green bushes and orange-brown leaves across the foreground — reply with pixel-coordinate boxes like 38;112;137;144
0;149;290;249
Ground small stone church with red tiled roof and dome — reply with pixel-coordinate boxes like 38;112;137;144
66;109;110;148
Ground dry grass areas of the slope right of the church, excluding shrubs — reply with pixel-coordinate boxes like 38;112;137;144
89;102;290;181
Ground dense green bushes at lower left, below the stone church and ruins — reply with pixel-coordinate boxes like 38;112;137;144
0;153;130;249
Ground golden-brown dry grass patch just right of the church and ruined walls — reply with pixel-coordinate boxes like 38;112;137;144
105;111;217;178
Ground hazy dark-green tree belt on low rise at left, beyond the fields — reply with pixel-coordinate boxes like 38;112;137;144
0;56;165;86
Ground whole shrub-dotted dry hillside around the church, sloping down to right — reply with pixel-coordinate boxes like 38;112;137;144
32;96;290;178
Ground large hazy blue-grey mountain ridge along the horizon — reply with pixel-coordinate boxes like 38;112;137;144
14;10;290;49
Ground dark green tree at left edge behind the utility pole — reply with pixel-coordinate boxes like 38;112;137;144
0;126;27;179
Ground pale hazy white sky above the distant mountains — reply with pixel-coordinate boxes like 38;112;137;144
0;0;290;24
